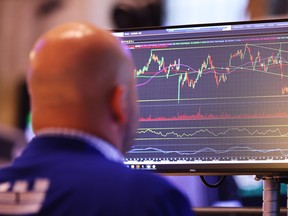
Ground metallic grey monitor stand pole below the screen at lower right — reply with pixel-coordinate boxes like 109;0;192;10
255;176;288;216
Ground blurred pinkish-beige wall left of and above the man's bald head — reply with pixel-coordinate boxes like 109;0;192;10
0;0;117;126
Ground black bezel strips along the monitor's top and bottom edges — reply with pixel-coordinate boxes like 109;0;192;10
112;19;288;176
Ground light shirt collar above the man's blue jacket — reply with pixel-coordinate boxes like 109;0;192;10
36;128;123;163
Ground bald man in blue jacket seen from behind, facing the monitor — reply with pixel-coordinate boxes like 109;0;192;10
0;23;192;216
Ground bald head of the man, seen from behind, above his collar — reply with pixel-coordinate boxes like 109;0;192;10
27;23;137;151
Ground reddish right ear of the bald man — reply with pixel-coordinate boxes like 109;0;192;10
111;85;127;124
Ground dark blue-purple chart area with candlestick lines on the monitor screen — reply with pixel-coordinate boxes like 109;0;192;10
125;32;288;165
